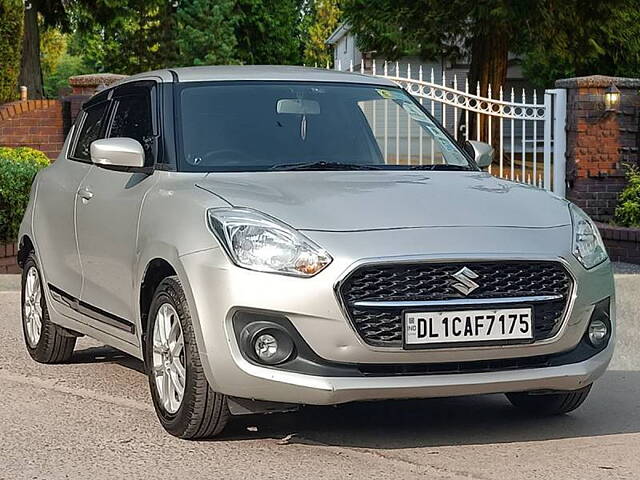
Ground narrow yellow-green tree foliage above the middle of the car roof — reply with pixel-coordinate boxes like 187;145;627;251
304;0;341;66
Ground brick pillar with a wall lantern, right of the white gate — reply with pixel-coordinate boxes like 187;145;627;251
556;75;640;222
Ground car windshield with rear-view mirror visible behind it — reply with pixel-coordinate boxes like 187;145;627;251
177;82;475;172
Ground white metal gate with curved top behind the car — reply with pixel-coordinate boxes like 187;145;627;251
337;61;566;196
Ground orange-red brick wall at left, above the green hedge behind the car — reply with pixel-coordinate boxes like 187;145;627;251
0;100;64;159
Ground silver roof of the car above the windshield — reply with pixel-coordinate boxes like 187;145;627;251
114;65;397;87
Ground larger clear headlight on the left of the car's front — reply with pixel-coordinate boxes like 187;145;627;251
208;208;332;277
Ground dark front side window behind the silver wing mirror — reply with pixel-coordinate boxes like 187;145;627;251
109;93;155;165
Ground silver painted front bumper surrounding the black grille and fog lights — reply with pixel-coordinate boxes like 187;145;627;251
180;227;615;404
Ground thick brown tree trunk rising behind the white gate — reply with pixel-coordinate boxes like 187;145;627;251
459;28;509;153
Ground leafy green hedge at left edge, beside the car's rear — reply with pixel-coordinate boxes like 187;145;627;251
0;147;49;243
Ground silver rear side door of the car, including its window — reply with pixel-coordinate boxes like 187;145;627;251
34;92;109;318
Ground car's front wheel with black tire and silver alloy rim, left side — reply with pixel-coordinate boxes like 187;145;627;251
145;276;230;440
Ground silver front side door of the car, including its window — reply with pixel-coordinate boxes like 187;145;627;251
76;82;159;344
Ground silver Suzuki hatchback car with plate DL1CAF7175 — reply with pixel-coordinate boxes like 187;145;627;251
19;66;615;438
